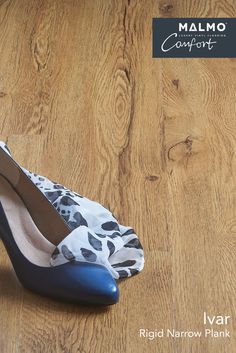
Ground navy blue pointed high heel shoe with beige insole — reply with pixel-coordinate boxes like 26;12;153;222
0;144;119;305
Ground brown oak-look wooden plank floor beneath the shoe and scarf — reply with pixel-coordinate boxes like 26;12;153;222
0;0;236;353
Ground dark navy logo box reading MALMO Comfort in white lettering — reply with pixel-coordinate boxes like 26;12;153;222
152;18;236;58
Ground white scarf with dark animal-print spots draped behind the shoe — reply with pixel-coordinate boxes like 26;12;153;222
0;142;144;279
